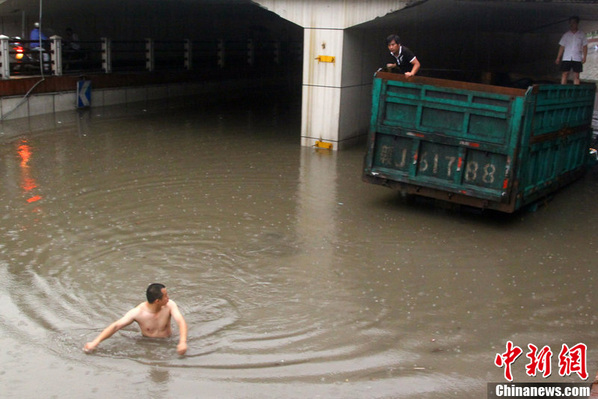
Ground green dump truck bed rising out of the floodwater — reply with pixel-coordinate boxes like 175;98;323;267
363;72;596;213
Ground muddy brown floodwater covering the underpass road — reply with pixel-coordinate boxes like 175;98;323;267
0;92;598;399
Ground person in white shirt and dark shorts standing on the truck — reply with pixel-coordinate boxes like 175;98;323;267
555;16;588;85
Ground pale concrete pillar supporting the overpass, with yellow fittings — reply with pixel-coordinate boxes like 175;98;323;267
254;0;411;150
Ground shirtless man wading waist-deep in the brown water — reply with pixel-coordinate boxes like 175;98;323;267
83;283;187;355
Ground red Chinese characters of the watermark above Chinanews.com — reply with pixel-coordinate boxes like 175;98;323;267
494;341;588;381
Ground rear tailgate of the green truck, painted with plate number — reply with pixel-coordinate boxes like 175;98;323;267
370;74;525;208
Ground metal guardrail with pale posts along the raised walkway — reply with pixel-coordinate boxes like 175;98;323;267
0;35;303;79
